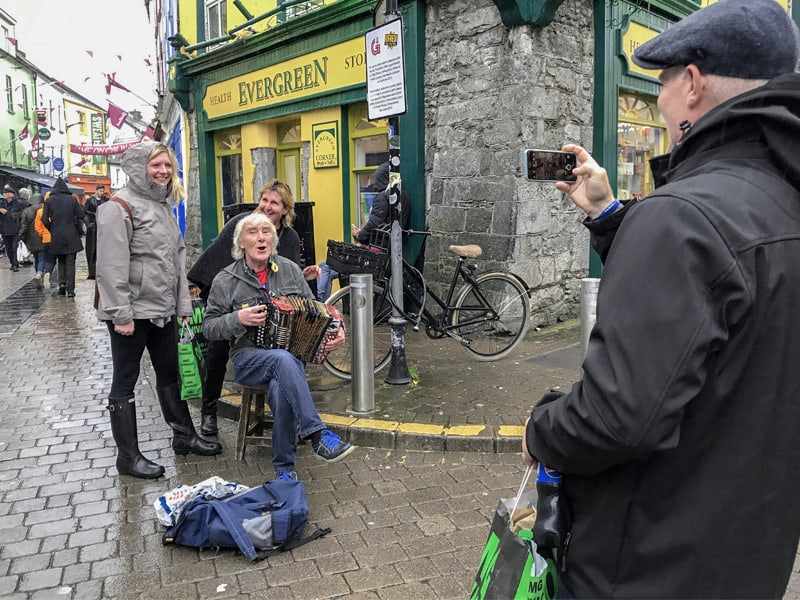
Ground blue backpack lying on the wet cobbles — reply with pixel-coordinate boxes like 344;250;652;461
162;479;331;560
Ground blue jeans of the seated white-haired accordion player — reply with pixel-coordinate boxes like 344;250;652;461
233;348;325;473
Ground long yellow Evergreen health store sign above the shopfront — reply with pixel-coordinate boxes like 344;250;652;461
203;37;366;119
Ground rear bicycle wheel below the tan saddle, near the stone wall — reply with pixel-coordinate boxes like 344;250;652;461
451;271;531;361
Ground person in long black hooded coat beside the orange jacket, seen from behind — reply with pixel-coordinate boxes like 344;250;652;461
42;177;83;298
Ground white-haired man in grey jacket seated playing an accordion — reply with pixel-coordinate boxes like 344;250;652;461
203;212;354;479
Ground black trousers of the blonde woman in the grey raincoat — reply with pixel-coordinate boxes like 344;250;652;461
108;318;178;400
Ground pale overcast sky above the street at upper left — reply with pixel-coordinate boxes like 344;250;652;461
0;0;156;121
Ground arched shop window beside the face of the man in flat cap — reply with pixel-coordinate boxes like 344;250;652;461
617;94;667;200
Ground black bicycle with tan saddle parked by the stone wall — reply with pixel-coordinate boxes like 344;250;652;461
325;231;530;379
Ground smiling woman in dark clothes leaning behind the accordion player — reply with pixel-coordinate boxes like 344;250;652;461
188;179;320;435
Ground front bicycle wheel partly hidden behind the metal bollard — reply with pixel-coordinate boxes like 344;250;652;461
325;284;392;379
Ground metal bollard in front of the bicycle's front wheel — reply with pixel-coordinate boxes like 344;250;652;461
347;273;375;414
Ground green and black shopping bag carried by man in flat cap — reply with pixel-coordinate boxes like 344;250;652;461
470;468;558;600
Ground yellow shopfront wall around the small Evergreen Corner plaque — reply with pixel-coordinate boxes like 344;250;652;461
300;107;342;263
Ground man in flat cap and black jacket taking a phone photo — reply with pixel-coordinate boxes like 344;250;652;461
523;0;800;598
